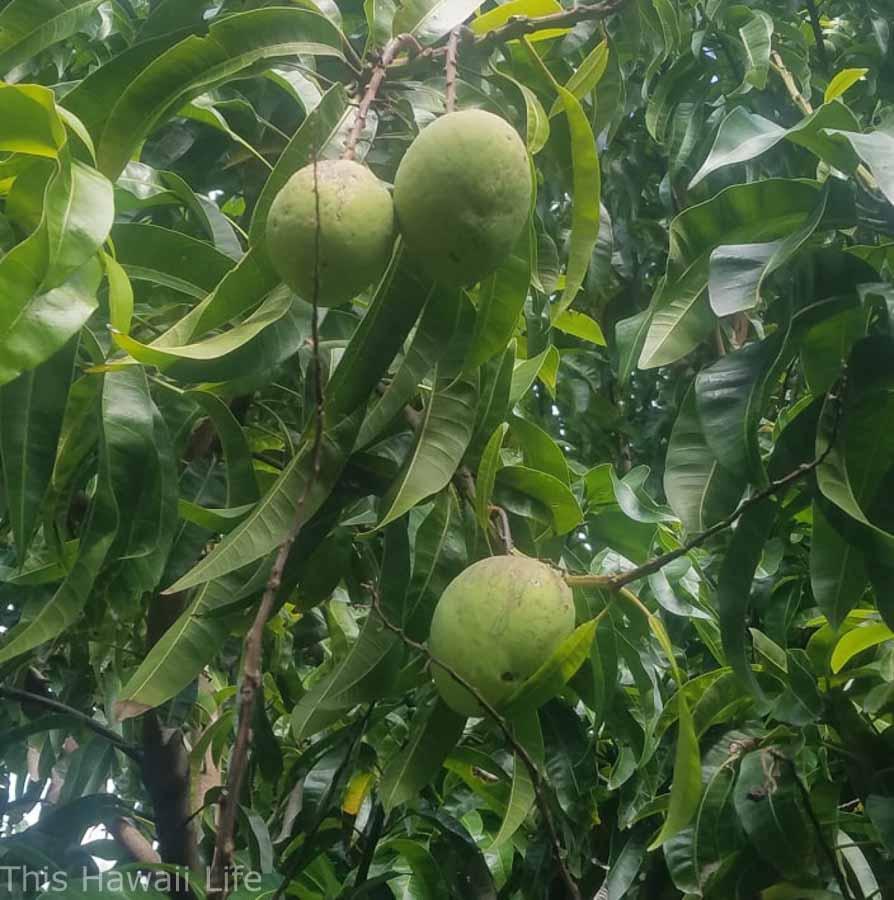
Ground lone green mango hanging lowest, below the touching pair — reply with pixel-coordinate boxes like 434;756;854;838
428;556;574;716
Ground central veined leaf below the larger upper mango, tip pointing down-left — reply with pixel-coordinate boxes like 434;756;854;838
379;370;478;528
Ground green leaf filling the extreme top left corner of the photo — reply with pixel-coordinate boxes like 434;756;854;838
0;0;102;74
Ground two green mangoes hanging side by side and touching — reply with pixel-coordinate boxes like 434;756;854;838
267;110;531;306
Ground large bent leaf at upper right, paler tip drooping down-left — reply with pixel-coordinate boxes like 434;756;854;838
639;178;820;369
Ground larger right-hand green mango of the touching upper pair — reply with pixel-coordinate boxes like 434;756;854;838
394;109;531;286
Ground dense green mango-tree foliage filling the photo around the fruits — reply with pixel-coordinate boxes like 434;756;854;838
0;0;894;900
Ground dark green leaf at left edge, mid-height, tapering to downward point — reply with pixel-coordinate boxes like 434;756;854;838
0;339;78;564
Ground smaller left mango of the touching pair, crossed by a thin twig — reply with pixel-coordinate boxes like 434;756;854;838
267;159;394;306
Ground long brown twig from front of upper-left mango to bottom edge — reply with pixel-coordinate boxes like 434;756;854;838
208;139;323;900
